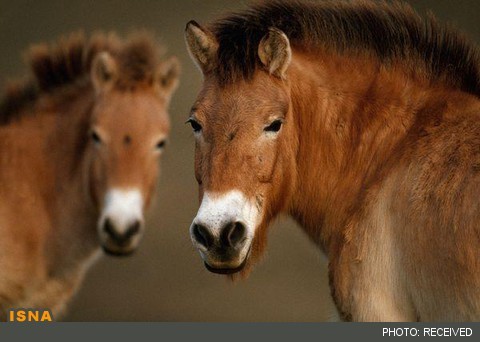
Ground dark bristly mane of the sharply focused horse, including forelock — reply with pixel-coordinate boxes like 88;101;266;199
210;0;480;95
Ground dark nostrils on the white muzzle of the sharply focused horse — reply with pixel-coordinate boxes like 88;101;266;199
192;221;247;250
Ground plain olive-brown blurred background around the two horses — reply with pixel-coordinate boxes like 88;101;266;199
0;0;480;321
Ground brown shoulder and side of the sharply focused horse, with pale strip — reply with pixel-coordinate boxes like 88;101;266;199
330;103;480;321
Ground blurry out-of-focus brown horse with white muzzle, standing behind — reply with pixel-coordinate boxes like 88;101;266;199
0;34;179;319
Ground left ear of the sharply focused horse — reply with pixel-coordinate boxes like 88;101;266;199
185;20;218;74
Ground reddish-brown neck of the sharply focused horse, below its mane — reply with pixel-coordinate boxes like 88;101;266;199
290;53;452;253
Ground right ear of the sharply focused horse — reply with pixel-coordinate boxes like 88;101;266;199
258;28;292;79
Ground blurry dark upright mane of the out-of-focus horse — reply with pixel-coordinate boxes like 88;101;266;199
0;32;162;125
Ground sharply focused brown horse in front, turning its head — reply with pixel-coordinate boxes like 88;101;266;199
186;1;480;321
